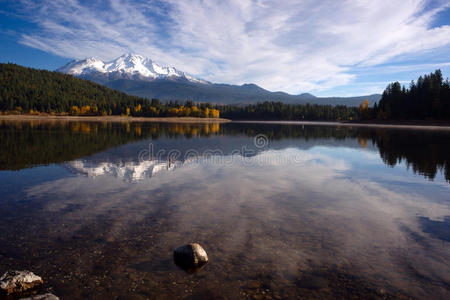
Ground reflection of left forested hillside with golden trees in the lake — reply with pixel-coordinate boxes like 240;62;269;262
0;121;219;170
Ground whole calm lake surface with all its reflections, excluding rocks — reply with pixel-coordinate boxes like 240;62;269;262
0;121;450;299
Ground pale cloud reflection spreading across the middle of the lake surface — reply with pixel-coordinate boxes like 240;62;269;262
27;148;450;296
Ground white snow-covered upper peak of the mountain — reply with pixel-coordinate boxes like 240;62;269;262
57;54;208;84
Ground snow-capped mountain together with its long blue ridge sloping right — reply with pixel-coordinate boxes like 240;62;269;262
57;54;381;106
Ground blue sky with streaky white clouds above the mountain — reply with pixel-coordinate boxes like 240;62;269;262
0;0;450;96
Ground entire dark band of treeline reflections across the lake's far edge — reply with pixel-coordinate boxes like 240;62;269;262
0;121;450;182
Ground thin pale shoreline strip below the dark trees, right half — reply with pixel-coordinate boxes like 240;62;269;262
232;120;450;131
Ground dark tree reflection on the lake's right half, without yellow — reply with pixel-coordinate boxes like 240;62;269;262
222;123;450;182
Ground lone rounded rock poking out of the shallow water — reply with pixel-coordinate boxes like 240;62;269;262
173;243;208;271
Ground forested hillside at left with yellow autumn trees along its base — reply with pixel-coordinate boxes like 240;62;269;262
0;64;219;118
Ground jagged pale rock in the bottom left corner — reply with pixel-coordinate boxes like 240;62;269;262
0;271;44;295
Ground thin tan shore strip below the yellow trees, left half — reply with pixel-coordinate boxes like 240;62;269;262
0;115;230;123
